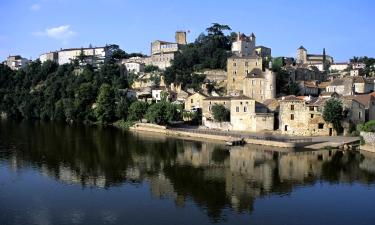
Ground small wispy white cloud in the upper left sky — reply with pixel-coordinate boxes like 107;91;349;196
33;25;77;44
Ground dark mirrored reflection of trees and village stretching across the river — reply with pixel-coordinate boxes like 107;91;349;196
0;121;375;221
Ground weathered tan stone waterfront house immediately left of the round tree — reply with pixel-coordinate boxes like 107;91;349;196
279;96;335;136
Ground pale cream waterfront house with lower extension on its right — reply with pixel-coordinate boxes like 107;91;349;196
230;96;274;132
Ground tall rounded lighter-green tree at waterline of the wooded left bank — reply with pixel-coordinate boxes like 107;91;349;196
95;84;115;124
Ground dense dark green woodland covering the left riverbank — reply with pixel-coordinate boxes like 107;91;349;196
0;60;128;122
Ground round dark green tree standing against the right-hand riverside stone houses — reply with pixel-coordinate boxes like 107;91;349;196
323;98;344;133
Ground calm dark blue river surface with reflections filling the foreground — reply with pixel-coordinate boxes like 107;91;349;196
0;121;375;225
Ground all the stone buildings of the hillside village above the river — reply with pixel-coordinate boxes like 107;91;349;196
4;31;375;136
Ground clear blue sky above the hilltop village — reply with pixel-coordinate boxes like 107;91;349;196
0;0;375;61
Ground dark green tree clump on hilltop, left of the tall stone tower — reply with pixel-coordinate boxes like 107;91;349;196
164;23;233;89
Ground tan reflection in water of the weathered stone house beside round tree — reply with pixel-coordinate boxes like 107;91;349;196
278;150;336;182
